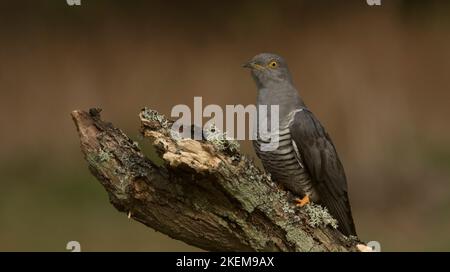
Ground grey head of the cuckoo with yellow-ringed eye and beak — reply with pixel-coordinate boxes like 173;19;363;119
243;53;291;86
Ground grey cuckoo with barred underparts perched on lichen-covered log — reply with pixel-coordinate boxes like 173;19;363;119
244;53;356;236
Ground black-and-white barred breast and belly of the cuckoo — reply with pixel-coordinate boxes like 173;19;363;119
253;127;318;201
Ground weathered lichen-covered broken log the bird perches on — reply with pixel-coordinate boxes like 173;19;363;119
72;109;357;251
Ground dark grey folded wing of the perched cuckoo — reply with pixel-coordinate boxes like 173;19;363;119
289;110;356;236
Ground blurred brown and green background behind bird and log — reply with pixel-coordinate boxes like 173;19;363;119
0;0;450;251
